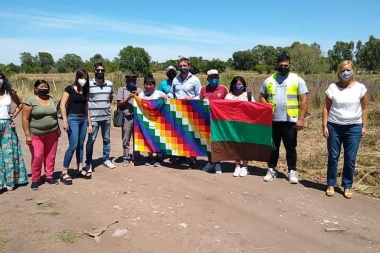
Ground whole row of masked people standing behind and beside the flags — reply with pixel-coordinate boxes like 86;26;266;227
0;53;367;198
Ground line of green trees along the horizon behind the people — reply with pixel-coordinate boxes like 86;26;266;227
0;35;380;75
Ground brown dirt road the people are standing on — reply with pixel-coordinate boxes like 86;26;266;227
0;117;380;253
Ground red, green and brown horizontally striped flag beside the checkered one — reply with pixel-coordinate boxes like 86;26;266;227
210;100;273;162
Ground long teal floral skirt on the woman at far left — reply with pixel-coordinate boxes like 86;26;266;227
0;120;28;190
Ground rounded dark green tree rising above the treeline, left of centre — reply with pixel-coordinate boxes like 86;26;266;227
115;46;151;75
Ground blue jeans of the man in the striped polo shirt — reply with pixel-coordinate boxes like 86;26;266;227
86;120;111;164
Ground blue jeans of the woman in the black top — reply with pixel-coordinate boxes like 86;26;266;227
63;114;87;169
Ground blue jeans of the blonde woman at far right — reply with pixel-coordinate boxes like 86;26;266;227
327;122;362;189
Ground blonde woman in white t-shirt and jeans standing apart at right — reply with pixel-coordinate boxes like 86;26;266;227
322;61;367;199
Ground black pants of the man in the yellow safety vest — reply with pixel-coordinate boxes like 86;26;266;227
268;122;297;171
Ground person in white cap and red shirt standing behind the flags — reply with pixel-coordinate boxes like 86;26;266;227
199;69;228;174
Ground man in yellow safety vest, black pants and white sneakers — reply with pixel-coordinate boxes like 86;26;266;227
260;52;308;184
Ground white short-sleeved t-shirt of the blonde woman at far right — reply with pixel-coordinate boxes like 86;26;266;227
326;82;367;125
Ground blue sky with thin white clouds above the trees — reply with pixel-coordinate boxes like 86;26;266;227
0;0;380;65
